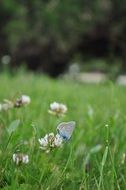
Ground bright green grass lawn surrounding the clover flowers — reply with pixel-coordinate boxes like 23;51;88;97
0;73;126;190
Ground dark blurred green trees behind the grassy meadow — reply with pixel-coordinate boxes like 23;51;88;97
0;0;126;77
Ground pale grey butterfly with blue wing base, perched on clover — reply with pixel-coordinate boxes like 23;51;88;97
57;121;76;140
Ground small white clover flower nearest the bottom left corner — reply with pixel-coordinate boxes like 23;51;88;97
13;153;29;165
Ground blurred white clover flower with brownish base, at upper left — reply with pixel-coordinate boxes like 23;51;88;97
15;95;31;107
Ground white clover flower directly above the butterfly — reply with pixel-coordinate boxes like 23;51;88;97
49;102;67;116
